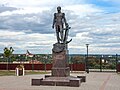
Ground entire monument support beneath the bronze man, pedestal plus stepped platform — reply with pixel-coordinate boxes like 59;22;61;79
31;43;86;87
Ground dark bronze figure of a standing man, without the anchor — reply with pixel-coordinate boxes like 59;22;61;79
52;6;67;43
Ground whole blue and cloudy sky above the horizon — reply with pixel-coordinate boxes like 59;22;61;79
0;0;120;54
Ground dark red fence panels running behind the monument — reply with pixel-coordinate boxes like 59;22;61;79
0;63;85;71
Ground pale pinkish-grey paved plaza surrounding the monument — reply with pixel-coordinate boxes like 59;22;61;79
0;72;120;90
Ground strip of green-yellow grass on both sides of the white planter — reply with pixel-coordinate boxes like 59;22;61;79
0;70;49;76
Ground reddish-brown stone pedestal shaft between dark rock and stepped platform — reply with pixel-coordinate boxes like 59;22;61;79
52;50;70;77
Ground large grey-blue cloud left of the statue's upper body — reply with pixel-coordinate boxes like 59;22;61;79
0;11;53;33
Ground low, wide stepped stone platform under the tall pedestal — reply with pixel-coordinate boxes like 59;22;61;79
31;76;82;87
